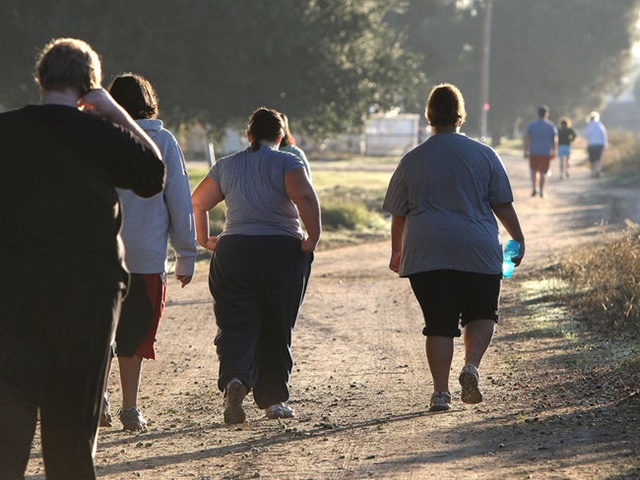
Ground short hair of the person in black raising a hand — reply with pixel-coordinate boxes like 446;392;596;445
36;38;102;96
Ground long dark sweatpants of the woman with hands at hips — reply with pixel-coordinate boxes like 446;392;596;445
209;235;313;408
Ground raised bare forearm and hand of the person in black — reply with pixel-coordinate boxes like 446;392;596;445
78;88;162;158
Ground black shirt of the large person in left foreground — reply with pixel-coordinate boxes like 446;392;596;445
0;105;164;289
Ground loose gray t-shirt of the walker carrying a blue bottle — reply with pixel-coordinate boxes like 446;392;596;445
383;133;513;277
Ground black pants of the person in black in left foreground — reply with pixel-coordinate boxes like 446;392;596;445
0;285;122;480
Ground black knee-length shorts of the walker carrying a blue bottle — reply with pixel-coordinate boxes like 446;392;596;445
409;270;502;337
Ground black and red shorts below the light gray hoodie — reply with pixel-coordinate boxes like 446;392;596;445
116;273;167;358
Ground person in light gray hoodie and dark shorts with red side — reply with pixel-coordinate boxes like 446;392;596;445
101;73;197;431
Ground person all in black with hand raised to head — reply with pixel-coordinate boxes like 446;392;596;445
0;38;164;480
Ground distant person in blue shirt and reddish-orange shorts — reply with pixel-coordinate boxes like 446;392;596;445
524;105;558;198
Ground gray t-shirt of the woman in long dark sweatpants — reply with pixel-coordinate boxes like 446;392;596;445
208;145;304;238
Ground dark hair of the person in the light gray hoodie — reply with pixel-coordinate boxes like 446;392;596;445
109;72;158;120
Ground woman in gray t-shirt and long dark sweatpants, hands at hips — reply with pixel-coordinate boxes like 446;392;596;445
192;107;321;424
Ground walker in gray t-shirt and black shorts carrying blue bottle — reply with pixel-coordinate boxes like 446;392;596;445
383;83;525;411
